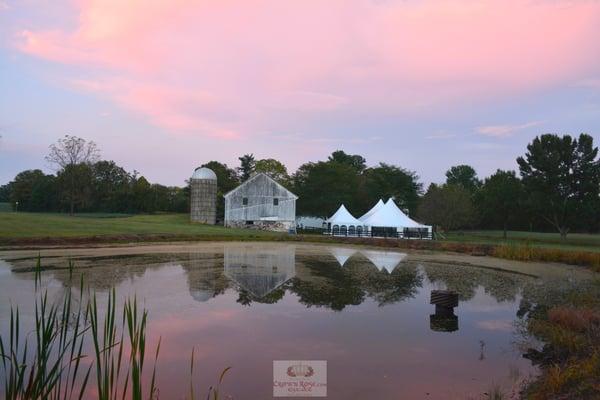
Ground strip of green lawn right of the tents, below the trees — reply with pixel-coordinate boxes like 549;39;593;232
444;231;600;252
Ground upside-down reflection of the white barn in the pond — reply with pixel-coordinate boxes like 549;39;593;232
224;246;296;299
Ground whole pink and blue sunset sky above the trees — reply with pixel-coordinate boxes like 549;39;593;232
0;0;600;185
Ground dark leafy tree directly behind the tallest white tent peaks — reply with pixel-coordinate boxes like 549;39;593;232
365;163;422;214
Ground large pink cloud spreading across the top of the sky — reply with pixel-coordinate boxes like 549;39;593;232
11;0;600;138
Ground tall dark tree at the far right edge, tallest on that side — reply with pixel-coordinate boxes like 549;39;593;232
517;134;600;239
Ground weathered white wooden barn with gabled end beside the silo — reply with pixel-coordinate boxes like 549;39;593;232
224;173;298;232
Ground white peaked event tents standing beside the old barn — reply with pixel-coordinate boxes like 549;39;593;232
325;199;432;239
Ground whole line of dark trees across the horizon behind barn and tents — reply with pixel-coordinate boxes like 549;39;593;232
0;134;600;237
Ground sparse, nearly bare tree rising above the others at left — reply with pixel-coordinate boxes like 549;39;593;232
46;135;100;215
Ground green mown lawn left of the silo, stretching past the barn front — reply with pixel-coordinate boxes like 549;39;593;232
0;213;277;239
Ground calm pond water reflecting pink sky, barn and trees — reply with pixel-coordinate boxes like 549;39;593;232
0;243;592;399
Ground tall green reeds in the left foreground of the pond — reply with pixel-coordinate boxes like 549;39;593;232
0;257;229;400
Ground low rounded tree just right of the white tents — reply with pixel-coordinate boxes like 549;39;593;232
417;184;475;231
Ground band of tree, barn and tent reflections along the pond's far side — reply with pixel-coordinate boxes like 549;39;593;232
17;244;537;314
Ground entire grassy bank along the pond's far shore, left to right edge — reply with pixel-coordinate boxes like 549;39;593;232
0;212;600;272
